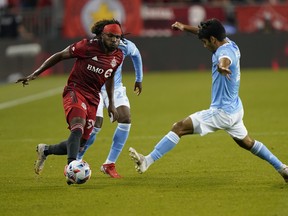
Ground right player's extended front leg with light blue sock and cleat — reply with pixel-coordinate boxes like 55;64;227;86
129;116;194;173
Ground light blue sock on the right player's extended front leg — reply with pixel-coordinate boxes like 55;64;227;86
150;131;180;161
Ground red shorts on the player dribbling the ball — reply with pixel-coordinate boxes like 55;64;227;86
63;90;98;140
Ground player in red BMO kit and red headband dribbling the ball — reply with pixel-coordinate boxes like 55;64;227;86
17;19;124;184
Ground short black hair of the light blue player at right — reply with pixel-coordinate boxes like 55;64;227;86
198;19;226;41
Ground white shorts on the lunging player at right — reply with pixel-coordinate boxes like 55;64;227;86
189;109;248;140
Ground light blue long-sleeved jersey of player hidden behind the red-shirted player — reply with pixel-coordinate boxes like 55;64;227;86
102;39;143;90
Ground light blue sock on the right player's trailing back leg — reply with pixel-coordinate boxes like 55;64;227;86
250;140;283;171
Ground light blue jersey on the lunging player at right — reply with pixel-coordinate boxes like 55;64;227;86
210;38;242;114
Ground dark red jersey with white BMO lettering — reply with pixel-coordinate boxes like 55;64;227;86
67;39;123;104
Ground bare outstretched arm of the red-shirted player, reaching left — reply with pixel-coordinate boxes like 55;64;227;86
16;47;72;86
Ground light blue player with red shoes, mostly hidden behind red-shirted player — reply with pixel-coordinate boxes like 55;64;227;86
77;22;143;178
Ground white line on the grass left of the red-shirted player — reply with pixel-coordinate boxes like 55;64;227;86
0;87;63;110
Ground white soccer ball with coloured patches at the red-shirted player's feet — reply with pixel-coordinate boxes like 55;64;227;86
64;160;91;184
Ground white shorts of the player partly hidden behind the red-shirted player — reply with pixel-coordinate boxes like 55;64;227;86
96;85;130;118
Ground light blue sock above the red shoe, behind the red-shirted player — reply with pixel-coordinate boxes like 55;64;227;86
105;123;131;164
